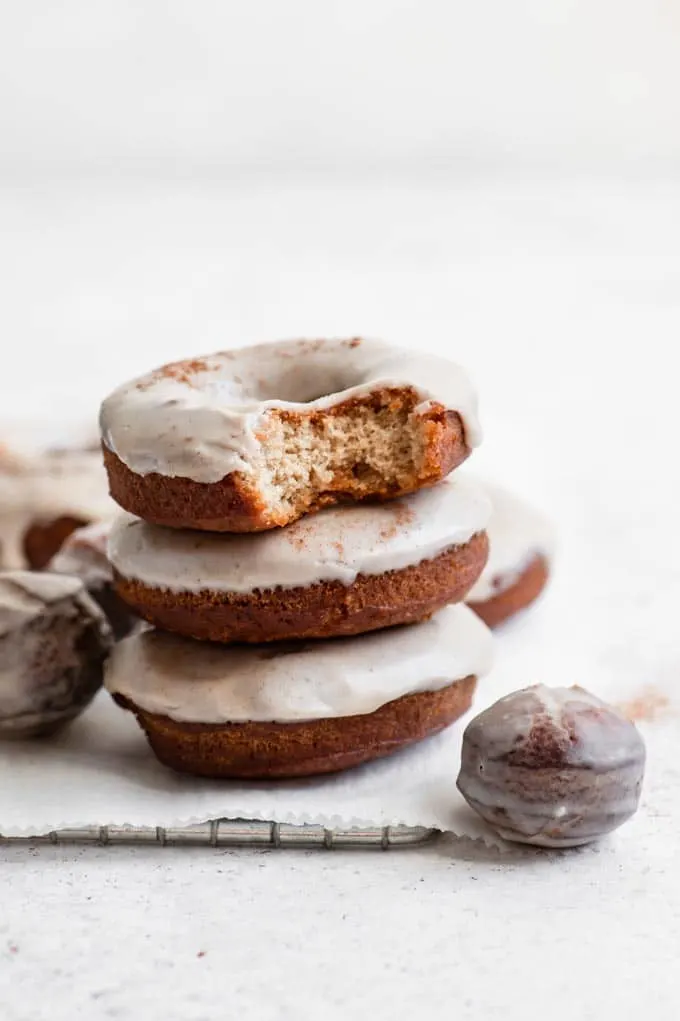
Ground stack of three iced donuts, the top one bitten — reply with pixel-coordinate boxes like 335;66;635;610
101;338;498;778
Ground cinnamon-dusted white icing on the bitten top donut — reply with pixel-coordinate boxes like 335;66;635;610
100;339;481;483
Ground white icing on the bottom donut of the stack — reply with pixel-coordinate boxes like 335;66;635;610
104;605;492;724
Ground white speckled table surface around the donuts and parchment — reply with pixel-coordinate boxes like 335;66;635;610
0;182;680;1021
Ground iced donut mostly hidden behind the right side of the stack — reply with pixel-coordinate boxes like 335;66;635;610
466;479;555;628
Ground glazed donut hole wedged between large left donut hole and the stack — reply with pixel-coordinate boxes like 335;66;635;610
47;520;138;638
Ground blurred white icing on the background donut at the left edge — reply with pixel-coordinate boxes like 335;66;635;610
0;448;116;570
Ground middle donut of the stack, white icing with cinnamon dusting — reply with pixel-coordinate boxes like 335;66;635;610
108;477;491;642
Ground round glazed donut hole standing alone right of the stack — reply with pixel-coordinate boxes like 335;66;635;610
457;684;645;847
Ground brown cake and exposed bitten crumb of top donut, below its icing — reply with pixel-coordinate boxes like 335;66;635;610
104;387;470;532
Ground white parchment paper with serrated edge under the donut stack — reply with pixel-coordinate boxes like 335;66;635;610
0;596;675;845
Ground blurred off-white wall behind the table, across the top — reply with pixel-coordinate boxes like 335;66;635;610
0;0;680;179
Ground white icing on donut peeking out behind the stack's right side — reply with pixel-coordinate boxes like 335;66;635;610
466;472;555;602
